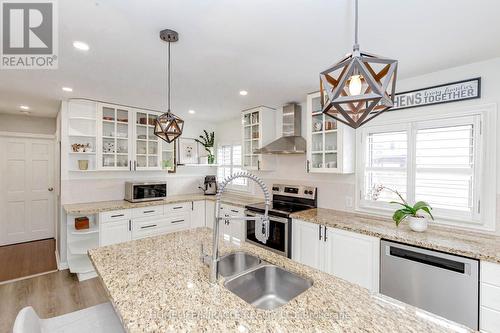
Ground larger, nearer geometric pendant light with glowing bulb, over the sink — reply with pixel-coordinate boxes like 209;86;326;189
320;0;398;128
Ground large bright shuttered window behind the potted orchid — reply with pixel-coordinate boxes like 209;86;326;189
358;114;483;225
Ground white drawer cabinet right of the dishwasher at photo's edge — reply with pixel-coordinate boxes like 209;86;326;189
479;261;500;333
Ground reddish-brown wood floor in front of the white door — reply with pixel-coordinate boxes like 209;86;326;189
0;238;57;282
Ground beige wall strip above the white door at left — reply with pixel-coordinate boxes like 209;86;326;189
0;113;56;134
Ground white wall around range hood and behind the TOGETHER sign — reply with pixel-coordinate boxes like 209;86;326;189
217;58;500;233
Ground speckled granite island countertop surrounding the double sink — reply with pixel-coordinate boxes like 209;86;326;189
89;228;470;333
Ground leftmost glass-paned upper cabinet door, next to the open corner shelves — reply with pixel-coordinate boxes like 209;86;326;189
98;104;133;170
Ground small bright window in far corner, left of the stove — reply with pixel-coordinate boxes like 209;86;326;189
217;145;248;191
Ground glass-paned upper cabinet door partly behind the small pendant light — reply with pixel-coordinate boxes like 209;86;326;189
134;110;163;170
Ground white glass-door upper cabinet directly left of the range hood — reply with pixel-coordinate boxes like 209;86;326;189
241;106;276;171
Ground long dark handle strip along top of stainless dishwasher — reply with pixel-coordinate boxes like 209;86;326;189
385;245;471;275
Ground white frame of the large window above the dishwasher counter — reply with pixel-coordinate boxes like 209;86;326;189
355;104;497;231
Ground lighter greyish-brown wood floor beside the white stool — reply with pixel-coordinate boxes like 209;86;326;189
0;270;108;333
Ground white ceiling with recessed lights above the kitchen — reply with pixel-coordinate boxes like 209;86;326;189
0;0;500;121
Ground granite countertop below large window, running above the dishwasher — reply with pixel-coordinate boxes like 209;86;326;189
292;208;500;263
